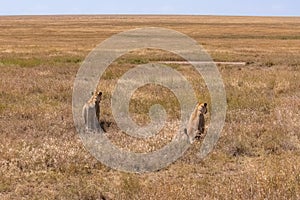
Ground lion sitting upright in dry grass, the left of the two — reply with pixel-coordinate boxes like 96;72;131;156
82;92;102;131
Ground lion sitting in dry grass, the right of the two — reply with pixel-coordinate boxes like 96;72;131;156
184;103;207;144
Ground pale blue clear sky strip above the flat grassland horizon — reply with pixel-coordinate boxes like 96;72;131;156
0;0;300;16
